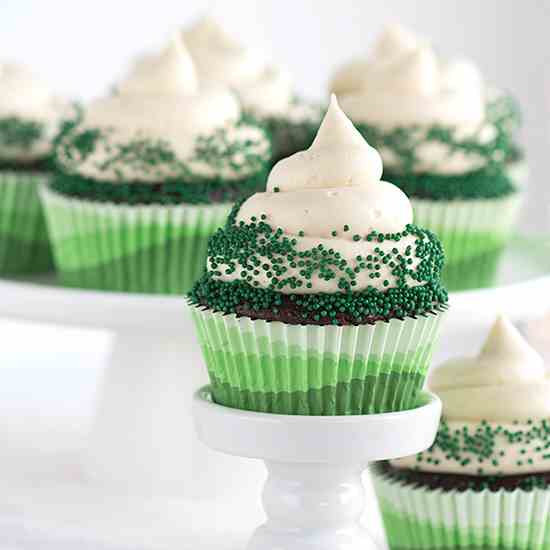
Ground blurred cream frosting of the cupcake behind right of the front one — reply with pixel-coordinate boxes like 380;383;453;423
330;25;511;178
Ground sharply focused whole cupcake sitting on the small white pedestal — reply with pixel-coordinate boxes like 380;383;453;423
189;97;447;415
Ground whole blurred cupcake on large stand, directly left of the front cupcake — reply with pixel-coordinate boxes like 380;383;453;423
42;38;271;293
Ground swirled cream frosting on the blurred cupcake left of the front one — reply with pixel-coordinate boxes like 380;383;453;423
57;37;270;185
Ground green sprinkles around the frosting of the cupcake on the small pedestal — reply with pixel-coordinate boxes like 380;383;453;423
191;204;448;323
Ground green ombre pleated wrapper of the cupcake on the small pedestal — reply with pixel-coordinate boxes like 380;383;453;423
192;306;444;415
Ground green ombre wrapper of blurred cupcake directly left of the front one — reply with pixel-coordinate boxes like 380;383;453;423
41;187;231;294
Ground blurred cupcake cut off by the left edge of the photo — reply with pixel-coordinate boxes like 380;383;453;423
0;63;66;275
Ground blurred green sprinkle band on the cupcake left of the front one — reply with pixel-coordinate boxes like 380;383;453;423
55;118;271;203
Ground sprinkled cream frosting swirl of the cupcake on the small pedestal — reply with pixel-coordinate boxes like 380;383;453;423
194;97;447;324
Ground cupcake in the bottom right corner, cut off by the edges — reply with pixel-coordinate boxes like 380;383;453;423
373;318;550;550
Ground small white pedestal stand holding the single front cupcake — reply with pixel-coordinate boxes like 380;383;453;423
193;386;441;550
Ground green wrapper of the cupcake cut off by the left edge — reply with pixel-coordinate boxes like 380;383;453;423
0;171;53;275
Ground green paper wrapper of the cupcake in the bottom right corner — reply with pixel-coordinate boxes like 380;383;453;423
372;473;550;550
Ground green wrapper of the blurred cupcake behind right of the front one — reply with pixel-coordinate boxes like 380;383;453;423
411;192;523;290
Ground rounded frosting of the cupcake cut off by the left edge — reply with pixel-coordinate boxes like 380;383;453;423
0;63;68;165
